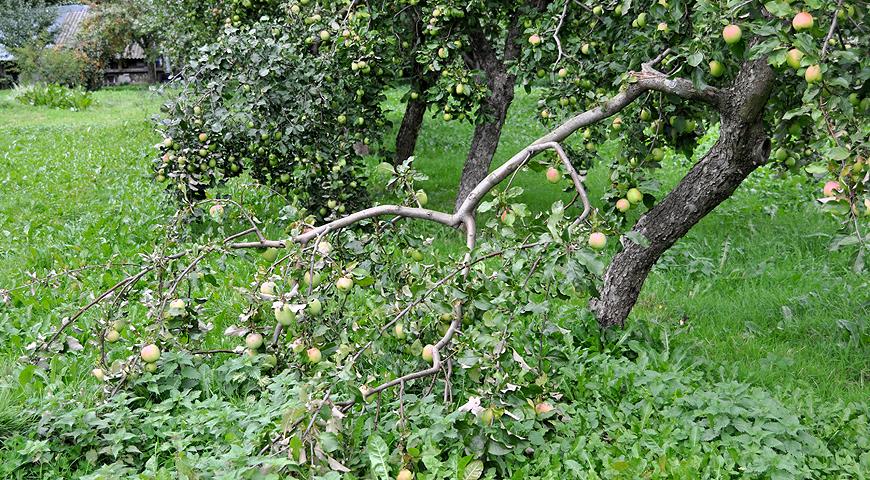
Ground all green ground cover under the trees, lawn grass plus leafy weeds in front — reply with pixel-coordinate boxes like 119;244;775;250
0;91;870;478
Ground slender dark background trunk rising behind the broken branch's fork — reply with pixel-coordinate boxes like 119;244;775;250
455;73;516;209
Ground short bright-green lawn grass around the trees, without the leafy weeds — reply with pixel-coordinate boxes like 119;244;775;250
0;85;870;433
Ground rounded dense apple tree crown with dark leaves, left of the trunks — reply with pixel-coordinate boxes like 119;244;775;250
155;3;386;218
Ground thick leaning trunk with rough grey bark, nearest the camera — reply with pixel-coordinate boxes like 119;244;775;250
590;59;774;327
